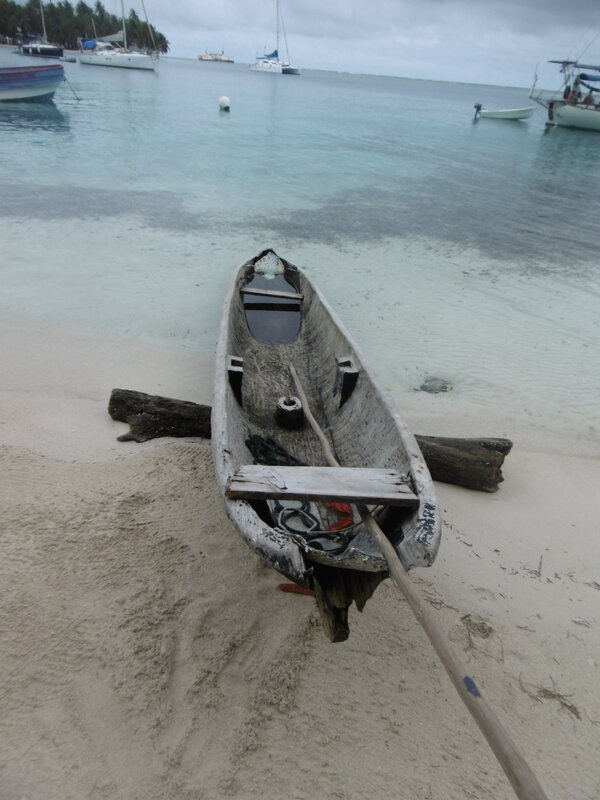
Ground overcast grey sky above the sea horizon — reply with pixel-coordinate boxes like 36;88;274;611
142;0;600;88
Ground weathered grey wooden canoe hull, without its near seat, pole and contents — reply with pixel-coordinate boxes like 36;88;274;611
211;251;441;620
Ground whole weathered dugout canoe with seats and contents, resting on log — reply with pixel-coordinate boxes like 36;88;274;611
211;250;441;641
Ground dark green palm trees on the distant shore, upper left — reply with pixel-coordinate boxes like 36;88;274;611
0;0;169;53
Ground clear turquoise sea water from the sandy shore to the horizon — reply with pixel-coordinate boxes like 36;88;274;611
0;48;600;456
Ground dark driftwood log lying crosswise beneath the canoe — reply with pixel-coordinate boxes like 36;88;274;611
108;389;512;492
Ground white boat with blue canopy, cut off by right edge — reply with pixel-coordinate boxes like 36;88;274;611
529;60;600;131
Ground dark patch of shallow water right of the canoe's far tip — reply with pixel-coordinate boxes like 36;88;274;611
246;179;600;277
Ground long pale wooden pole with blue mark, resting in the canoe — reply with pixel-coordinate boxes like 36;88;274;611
288;364;548;800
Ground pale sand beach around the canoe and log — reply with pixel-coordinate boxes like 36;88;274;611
0;318;600;800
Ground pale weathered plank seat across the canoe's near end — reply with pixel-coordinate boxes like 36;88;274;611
225;464;419;506
